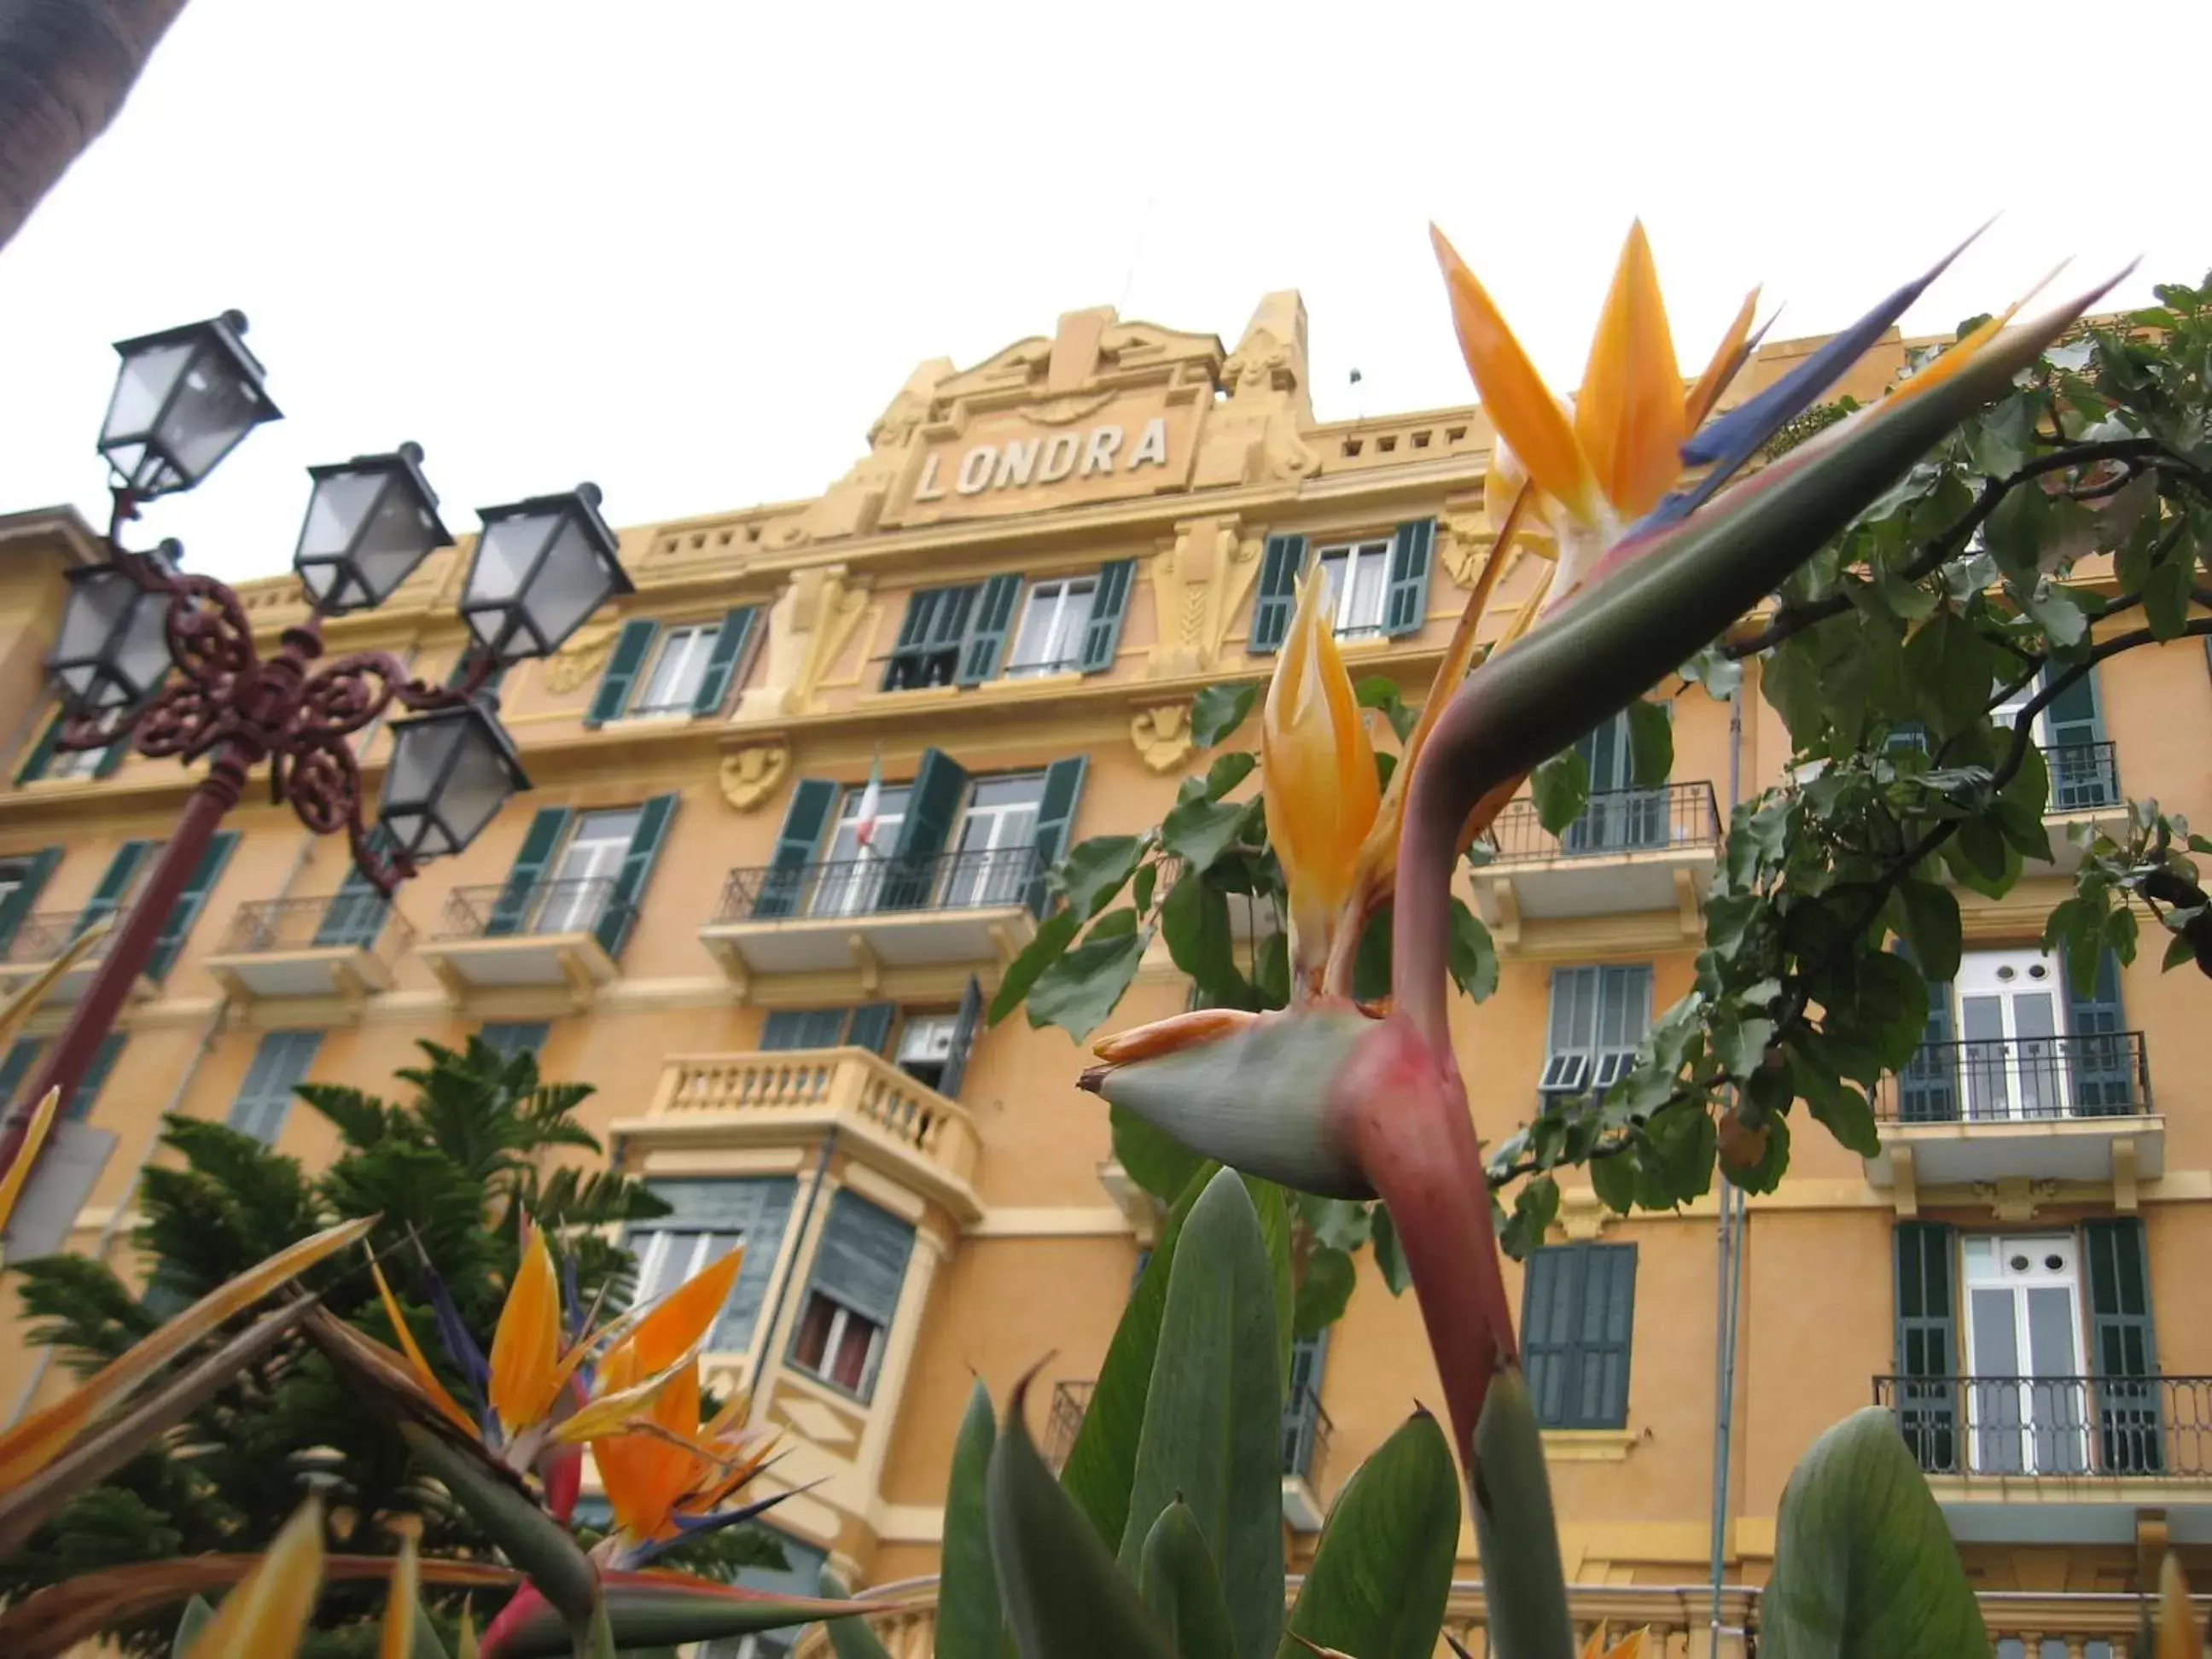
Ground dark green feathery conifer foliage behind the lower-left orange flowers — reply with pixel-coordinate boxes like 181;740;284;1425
0;1038;777;1655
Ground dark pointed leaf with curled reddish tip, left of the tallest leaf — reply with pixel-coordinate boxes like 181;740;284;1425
989;1378;1185;1659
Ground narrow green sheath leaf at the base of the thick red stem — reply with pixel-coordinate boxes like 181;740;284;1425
1473;1367;1575;1659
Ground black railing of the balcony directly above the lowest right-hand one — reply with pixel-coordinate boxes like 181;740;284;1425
1873;1031;2150;1124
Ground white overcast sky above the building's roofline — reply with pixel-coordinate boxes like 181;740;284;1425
0;0;2212;578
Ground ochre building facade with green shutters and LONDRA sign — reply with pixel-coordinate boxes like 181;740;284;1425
0;292;2212;1659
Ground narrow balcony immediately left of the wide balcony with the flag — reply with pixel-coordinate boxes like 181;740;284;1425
416;876;637;1009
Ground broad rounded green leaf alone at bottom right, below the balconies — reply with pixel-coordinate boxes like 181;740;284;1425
1759;1407;1988;1659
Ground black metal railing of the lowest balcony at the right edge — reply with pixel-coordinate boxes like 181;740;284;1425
1873;1376;2212;1477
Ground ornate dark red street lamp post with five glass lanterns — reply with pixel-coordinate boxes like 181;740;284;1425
0;311;631;1194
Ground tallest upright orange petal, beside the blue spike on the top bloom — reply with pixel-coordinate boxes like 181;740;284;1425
1575;219;1688;520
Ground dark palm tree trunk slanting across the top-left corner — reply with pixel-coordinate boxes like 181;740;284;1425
0;0;183;247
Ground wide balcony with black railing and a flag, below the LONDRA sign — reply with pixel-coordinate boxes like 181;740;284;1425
699;847;1044;1006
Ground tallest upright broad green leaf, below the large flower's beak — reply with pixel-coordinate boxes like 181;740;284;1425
1120;1170;1283;1659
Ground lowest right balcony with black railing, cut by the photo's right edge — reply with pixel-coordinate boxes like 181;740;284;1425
1873;1376;2212;1542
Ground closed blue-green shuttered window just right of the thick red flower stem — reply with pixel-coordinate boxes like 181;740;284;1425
1522;1243;1637;1429
